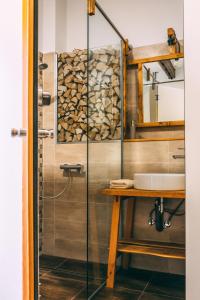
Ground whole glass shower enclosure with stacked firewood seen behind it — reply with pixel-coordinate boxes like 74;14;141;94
35;0;125;300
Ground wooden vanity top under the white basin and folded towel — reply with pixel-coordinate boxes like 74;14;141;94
102;189;185;199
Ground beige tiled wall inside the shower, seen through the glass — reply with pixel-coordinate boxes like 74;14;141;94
42;53;121;262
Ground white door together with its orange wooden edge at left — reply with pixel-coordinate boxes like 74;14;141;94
0;0;33;300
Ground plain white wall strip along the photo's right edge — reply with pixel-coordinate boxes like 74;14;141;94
184;0;200;300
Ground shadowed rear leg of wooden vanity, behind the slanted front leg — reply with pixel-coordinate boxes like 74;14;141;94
122;198;135;269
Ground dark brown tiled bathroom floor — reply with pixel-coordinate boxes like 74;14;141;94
40;256;185;300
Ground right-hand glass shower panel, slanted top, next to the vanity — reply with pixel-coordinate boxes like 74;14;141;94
88;7;123;298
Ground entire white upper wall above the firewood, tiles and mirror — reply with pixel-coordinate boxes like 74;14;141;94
39;0;183;52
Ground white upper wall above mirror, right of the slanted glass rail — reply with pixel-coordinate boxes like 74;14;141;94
98;0;183;47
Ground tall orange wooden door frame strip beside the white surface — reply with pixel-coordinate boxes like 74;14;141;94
22;0;37;300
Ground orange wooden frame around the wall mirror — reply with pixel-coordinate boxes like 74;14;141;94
128;53;185;128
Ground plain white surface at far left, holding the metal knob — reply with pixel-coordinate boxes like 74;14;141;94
0;0;22;300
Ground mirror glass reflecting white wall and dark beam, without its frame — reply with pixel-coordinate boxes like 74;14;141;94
143;58;184;123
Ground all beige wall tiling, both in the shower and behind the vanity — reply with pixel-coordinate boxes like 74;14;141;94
42;43;185;273
